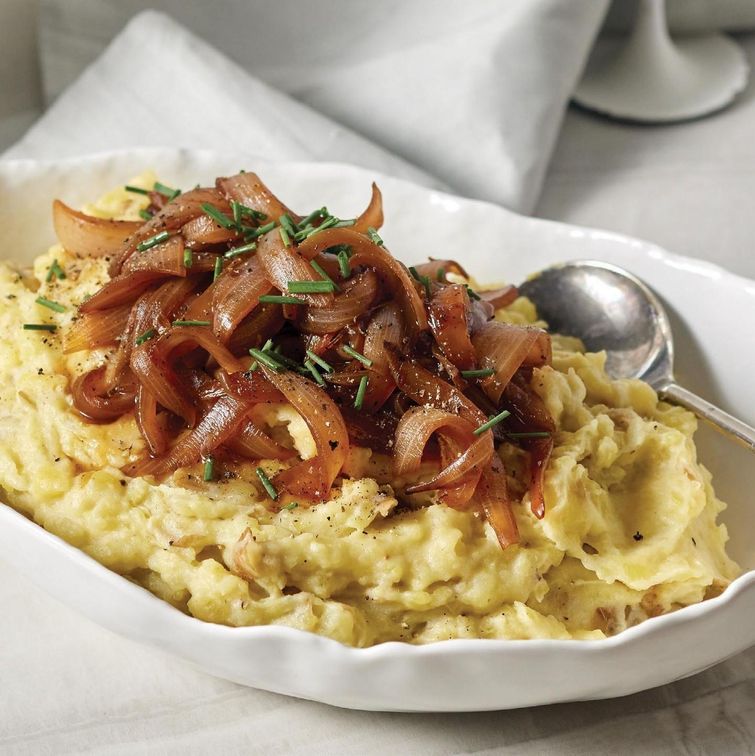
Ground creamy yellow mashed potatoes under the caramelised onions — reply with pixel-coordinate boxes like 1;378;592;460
0;176;738;646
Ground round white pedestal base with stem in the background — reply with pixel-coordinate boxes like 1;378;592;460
573;0;749;123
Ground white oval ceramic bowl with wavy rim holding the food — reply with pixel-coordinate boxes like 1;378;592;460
0;150;755;711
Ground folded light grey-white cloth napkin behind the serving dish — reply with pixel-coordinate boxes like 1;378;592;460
11;0;607;212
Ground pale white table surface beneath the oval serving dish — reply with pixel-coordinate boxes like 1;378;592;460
0;37;755;754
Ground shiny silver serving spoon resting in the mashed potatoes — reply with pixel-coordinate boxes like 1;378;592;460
519;260;755;451
